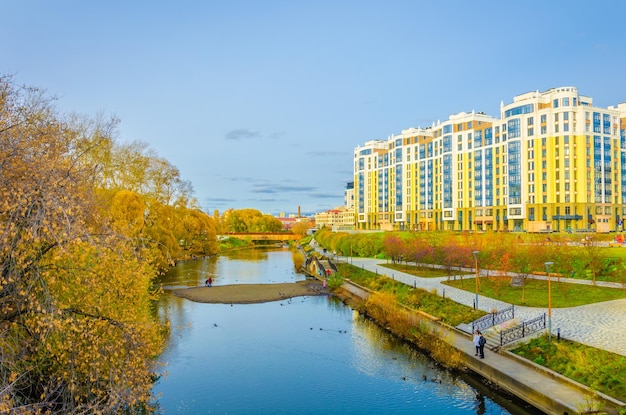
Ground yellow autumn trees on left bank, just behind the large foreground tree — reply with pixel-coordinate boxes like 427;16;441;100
72;117;219;272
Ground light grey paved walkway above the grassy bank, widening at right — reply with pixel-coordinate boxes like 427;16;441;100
326;256;626;356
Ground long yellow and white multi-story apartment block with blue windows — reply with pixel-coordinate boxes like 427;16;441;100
354;87;626;232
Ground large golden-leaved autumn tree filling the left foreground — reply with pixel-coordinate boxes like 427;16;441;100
0;77;163;414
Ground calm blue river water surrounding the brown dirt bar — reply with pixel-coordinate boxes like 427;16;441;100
154;249;541;415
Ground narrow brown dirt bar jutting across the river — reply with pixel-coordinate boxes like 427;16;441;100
173;279;328;304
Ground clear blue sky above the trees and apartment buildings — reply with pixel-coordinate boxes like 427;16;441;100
0;0;626;218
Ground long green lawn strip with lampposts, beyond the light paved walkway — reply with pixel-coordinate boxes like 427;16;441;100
444;277;626;308
